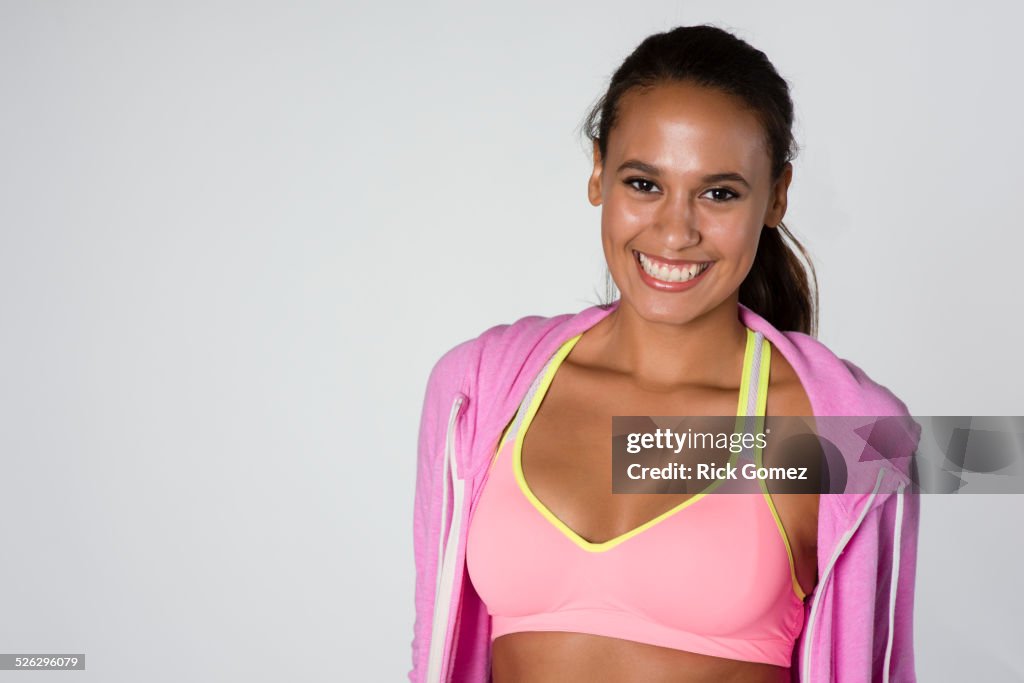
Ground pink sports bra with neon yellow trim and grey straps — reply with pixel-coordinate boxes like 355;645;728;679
467;330;804;667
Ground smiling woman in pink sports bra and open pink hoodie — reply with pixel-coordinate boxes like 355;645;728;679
410;26;918;683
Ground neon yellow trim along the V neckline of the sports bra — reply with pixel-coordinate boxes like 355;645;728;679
512;330;754;553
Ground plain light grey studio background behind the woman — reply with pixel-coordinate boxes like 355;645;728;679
0;1;1024;682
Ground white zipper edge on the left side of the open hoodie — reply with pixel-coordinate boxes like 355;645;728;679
426;393;466;683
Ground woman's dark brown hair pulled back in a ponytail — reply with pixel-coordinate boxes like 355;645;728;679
584;25;818;336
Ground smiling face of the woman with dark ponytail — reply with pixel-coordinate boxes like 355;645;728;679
588;83;792;325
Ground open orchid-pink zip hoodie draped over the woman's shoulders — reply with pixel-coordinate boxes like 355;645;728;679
409;302;920;683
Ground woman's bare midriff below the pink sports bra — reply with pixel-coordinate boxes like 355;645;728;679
492;632;790;683
